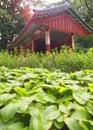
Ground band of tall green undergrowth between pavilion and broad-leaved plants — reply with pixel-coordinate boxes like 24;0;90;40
0;48;93;72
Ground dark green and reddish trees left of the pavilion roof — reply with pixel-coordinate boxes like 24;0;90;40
0;0;46;49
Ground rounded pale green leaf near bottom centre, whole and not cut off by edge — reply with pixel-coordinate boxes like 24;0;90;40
43;105;60;121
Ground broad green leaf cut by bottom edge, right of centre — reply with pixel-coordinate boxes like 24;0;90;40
64;118;84;130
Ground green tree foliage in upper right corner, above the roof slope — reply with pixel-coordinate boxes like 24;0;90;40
71;0;93;26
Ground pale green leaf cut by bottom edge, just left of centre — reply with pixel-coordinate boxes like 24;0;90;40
29;115;45;130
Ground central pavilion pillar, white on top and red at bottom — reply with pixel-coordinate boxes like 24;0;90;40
45;31;51;52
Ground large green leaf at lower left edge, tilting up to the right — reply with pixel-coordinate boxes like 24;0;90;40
0;102;20;122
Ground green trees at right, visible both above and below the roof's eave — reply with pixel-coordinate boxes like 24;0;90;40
71;0;93;49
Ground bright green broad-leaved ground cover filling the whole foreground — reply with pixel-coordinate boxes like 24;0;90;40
0;67;93;130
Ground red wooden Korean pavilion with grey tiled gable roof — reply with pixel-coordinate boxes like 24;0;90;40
8;4;93;53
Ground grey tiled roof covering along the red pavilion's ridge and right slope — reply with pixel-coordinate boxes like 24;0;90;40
32;4;93;33
